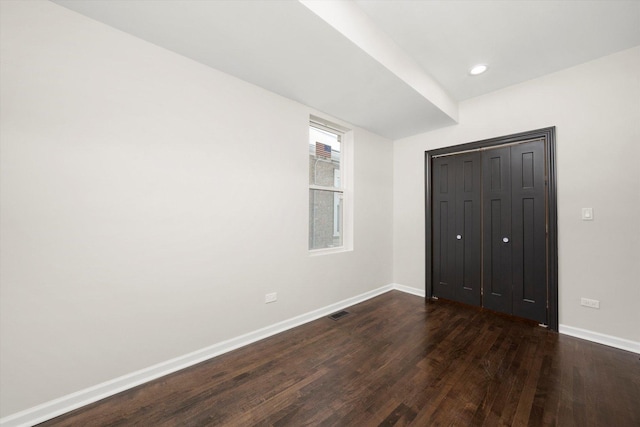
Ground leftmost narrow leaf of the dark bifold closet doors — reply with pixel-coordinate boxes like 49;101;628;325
432;156;457;299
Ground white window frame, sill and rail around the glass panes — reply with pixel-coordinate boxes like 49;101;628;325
307;116;353;256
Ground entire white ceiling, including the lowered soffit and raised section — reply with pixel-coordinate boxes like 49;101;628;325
53;0;640;139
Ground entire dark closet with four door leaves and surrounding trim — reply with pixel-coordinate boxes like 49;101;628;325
426;128;557;329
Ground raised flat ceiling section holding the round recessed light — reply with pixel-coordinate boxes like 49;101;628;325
357;0;640;100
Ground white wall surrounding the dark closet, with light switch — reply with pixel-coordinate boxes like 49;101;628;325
394;47;640;342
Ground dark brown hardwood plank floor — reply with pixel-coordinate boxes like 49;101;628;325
42;291;640;427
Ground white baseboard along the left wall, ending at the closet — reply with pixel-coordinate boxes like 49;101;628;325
0;284;410;427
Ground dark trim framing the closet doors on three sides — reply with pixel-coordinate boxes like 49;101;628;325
424;126;558;332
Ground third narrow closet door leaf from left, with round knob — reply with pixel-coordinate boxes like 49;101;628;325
482;147;513;314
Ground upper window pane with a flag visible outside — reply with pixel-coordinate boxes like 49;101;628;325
309;127;341;188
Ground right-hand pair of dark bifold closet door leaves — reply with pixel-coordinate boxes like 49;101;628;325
482;140;547;323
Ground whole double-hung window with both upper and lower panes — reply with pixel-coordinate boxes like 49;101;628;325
309;119;349;252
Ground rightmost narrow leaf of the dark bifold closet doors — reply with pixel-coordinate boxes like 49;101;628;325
511;140;547;323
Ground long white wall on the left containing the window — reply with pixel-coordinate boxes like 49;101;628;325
0;1;396;416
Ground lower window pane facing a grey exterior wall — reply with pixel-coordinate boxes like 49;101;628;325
309;190;342;249
